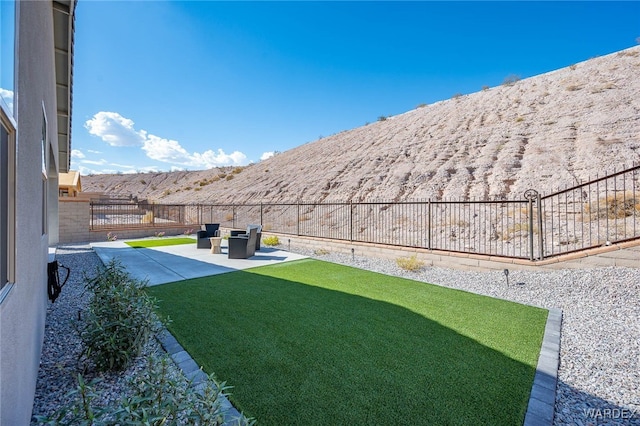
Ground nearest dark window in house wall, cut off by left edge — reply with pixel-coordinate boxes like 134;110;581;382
0;110;16;294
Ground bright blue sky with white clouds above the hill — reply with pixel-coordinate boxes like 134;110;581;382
71;0;640;174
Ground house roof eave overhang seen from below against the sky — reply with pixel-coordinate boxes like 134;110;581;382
53;0;76;173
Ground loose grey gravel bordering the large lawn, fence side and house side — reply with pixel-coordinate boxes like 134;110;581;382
34;246;640;425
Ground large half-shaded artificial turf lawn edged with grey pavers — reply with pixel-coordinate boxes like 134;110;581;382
148;259;547;425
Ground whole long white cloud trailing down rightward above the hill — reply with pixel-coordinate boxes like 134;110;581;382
85;111;247;170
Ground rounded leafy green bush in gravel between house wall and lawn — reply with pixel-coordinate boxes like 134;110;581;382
79;260;158;371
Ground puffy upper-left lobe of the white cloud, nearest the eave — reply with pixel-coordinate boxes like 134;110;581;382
84;111;147;146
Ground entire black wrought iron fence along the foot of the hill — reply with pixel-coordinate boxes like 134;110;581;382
91;166;640;260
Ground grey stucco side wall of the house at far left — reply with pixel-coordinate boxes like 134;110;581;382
0;1;74;426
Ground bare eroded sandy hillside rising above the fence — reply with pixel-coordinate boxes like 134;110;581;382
83;46;640;204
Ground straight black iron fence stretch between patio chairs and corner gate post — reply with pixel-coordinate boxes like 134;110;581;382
255;200;537;258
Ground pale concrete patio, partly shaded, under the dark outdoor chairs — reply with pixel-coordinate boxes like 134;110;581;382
91;239;306;286
